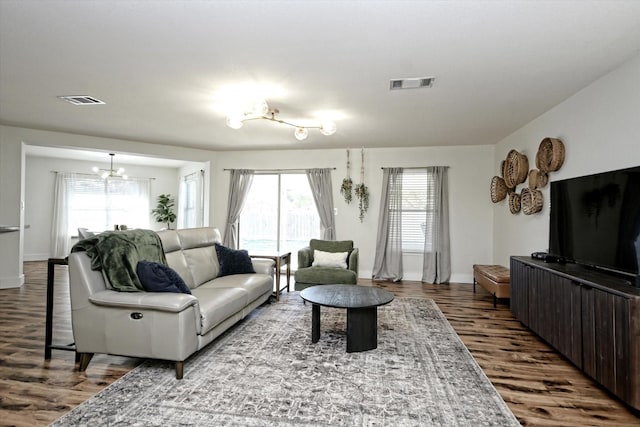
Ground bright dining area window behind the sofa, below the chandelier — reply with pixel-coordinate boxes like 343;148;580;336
65;175;150;236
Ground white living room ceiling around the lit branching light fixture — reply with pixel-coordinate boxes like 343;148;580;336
0;0;640;150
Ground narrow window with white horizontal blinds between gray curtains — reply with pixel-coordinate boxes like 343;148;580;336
400;169;434;252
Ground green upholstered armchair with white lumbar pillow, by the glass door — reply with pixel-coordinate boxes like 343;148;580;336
294;239;358;291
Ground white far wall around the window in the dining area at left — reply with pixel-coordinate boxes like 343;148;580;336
24;156;179;261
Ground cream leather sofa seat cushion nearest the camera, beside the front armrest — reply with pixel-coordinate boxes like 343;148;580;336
191;286;249;335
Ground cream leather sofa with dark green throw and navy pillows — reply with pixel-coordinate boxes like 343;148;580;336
69;227;274;379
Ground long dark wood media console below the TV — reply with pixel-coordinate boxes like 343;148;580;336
511;257;640;411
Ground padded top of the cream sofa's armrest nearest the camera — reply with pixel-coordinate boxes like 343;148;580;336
89;290;198;313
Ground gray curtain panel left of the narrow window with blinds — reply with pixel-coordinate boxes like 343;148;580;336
373;168;402;282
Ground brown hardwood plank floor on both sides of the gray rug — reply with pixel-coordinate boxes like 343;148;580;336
0;262;640;426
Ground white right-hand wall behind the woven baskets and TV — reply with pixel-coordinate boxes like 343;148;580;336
496;55;640;266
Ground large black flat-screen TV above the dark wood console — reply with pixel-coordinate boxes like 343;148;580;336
549;166;640;275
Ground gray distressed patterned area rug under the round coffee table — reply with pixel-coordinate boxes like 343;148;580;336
52;292;520;427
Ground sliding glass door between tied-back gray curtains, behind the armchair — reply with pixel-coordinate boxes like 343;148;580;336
239;173;320;261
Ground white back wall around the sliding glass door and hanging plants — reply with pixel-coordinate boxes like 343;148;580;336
212;146;493;283
